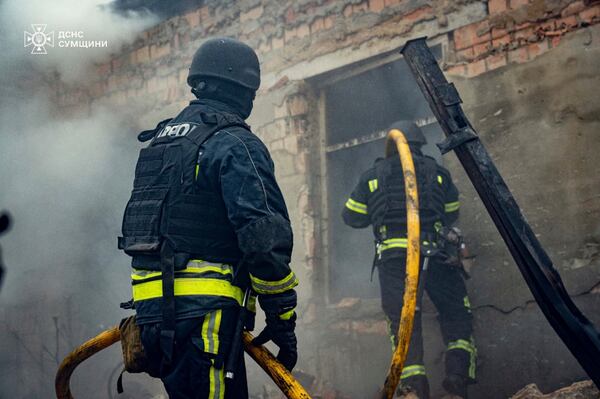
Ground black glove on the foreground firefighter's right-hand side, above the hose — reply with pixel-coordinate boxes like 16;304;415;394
252;290;298;371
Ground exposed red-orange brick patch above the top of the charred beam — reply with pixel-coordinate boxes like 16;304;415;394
446;0;600;77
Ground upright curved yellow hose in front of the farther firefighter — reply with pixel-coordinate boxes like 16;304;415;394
382;129;421;399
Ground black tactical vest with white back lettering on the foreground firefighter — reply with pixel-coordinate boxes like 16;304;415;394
119;106;249;270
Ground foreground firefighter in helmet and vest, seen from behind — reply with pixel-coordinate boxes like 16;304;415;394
119;38;298;399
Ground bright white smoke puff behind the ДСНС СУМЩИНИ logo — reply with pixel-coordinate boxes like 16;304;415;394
0;0;158;82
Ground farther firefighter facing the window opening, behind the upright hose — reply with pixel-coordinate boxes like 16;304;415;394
342;121;476;399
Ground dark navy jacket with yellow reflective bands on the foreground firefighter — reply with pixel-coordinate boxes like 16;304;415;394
123;100;298;324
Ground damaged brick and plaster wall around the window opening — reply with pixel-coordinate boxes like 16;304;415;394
35;0;600;398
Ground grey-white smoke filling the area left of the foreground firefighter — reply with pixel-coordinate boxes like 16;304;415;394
0;0;161;398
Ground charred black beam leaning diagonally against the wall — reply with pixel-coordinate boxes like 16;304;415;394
401;38;600;387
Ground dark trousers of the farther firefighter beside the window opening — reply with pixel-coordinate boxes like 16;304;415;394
377;257;477;399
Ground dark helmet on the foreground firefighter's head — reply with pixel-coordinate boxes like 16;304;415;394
187;37;260;91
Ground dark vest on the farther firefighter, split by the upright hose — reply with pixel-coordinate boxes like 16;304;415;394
367;155;444;240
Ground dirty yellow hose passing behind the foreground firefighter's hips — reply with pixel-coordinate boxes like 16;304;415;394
54;327;310;399
